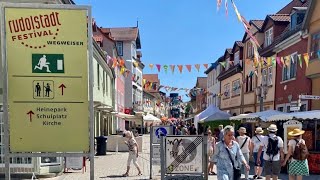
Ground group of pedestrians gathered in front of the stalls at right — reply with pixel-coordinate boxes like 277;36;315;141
208;124;309;180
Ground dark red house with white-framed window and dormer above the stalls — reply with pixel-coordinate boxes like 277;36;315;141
274;7;311;112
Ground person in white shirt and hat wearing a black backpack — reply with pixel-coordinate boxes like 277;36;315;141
257;124;284;180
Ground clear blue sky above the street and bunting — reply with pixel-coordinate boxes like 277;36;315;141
75;0;291;101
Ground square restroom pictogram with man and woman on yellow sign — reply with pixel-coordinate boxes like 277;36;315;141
32;80;54;99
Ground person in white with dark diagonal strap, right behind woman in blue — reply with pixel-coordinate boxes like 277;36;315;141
236;127;251;179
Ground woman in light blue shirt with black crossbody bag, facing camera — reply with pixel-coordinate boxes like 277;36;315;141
213;126;250;180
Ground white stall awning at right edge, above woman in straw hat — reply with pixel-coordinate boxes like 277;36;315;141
266;110;320;121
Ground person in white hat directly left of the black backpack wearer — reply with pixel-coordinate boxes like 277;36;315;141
251;127;265;179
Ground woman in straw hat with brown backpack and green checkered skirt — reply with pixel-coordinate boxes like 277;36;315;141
282;128;309;180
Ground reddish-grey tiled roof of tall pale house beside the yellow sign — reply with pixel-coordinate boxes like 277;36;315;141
101;27;139;41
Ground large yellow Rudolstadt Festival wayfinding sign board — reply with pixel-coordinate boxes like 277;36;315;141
4;7;91;152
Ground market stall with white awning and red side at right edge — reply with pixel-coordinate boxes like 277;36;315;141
266;110;320;174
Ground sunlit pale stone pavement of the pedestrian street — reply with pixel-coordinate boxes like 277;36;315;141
47;135;320;180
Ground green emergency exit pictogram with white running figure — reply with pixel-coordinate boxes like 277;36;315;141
31;54;64;73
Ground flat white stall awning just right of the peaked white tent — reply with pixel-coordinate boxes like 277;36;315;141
230;110;287;121
